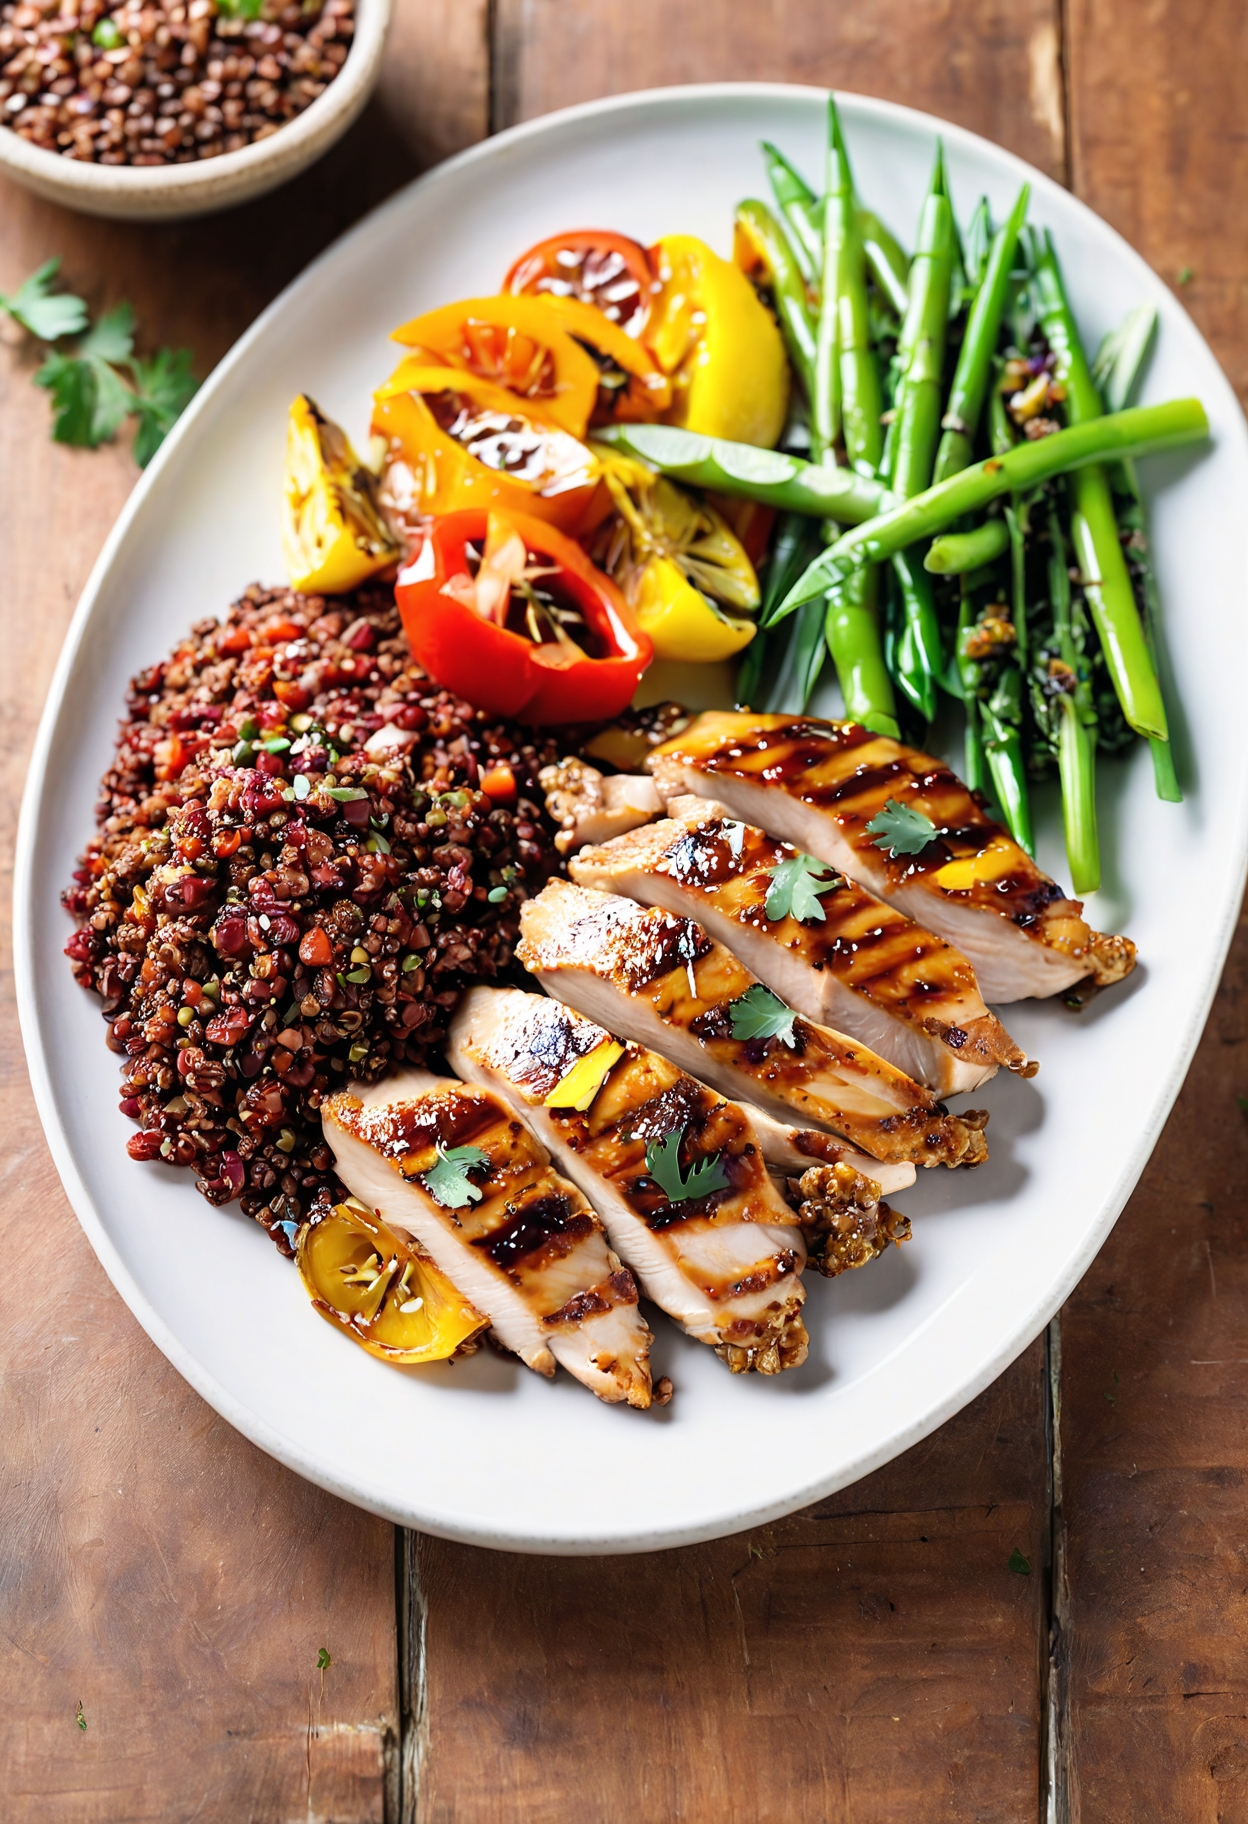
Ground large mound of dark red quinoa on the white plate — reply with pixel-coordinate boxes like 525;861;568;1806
64;586;558;1253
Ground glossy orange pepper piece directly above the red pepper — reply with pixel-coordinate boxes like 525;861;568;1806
372;361;609;533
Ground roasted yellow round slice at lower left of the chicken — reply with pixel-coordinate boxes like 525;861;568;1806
296;1197;489;1363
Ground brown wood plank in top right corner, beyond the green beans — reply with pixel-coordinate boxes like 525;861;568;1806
1069;0;1248;401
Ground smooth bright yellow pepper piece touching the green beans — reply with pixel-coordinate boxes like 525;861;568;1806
646;233;788;449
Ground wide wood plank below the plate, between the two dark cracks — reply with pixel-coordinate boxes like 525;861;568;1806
416;1342;1047;1824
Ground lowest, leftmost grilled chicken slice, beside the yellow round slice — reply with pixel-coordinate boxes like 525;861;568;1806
321;1071;651;1406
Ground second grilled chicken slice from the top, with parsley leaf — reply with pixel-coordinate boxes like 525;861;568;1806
569;817;1035;1096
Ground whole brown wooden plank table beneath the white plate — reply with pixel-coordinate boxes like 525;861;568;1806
0;0;1248;1824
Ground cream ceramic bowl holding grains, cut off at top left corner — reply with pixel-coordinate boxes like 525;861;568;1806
0;0;390;221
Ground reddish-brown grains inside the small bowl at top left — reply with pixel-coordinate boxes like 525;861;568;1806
0;0;356;164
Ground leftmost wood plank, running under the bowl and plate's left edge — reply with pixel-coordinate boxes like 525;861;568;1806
0;0;487;1824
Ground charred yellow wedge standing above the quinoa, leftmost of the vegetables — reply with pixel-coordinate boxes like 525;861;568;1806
281;392;405;595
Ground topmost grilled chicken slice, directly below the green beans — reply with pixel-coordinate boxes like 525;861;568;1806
648;713;1135;1001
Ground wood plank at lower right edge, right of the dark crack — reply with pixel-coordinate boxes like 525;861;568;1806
1062;908;1248;1824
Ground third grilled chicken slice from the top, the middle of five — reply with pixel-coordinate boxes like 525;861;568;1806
518;879;987;1167
